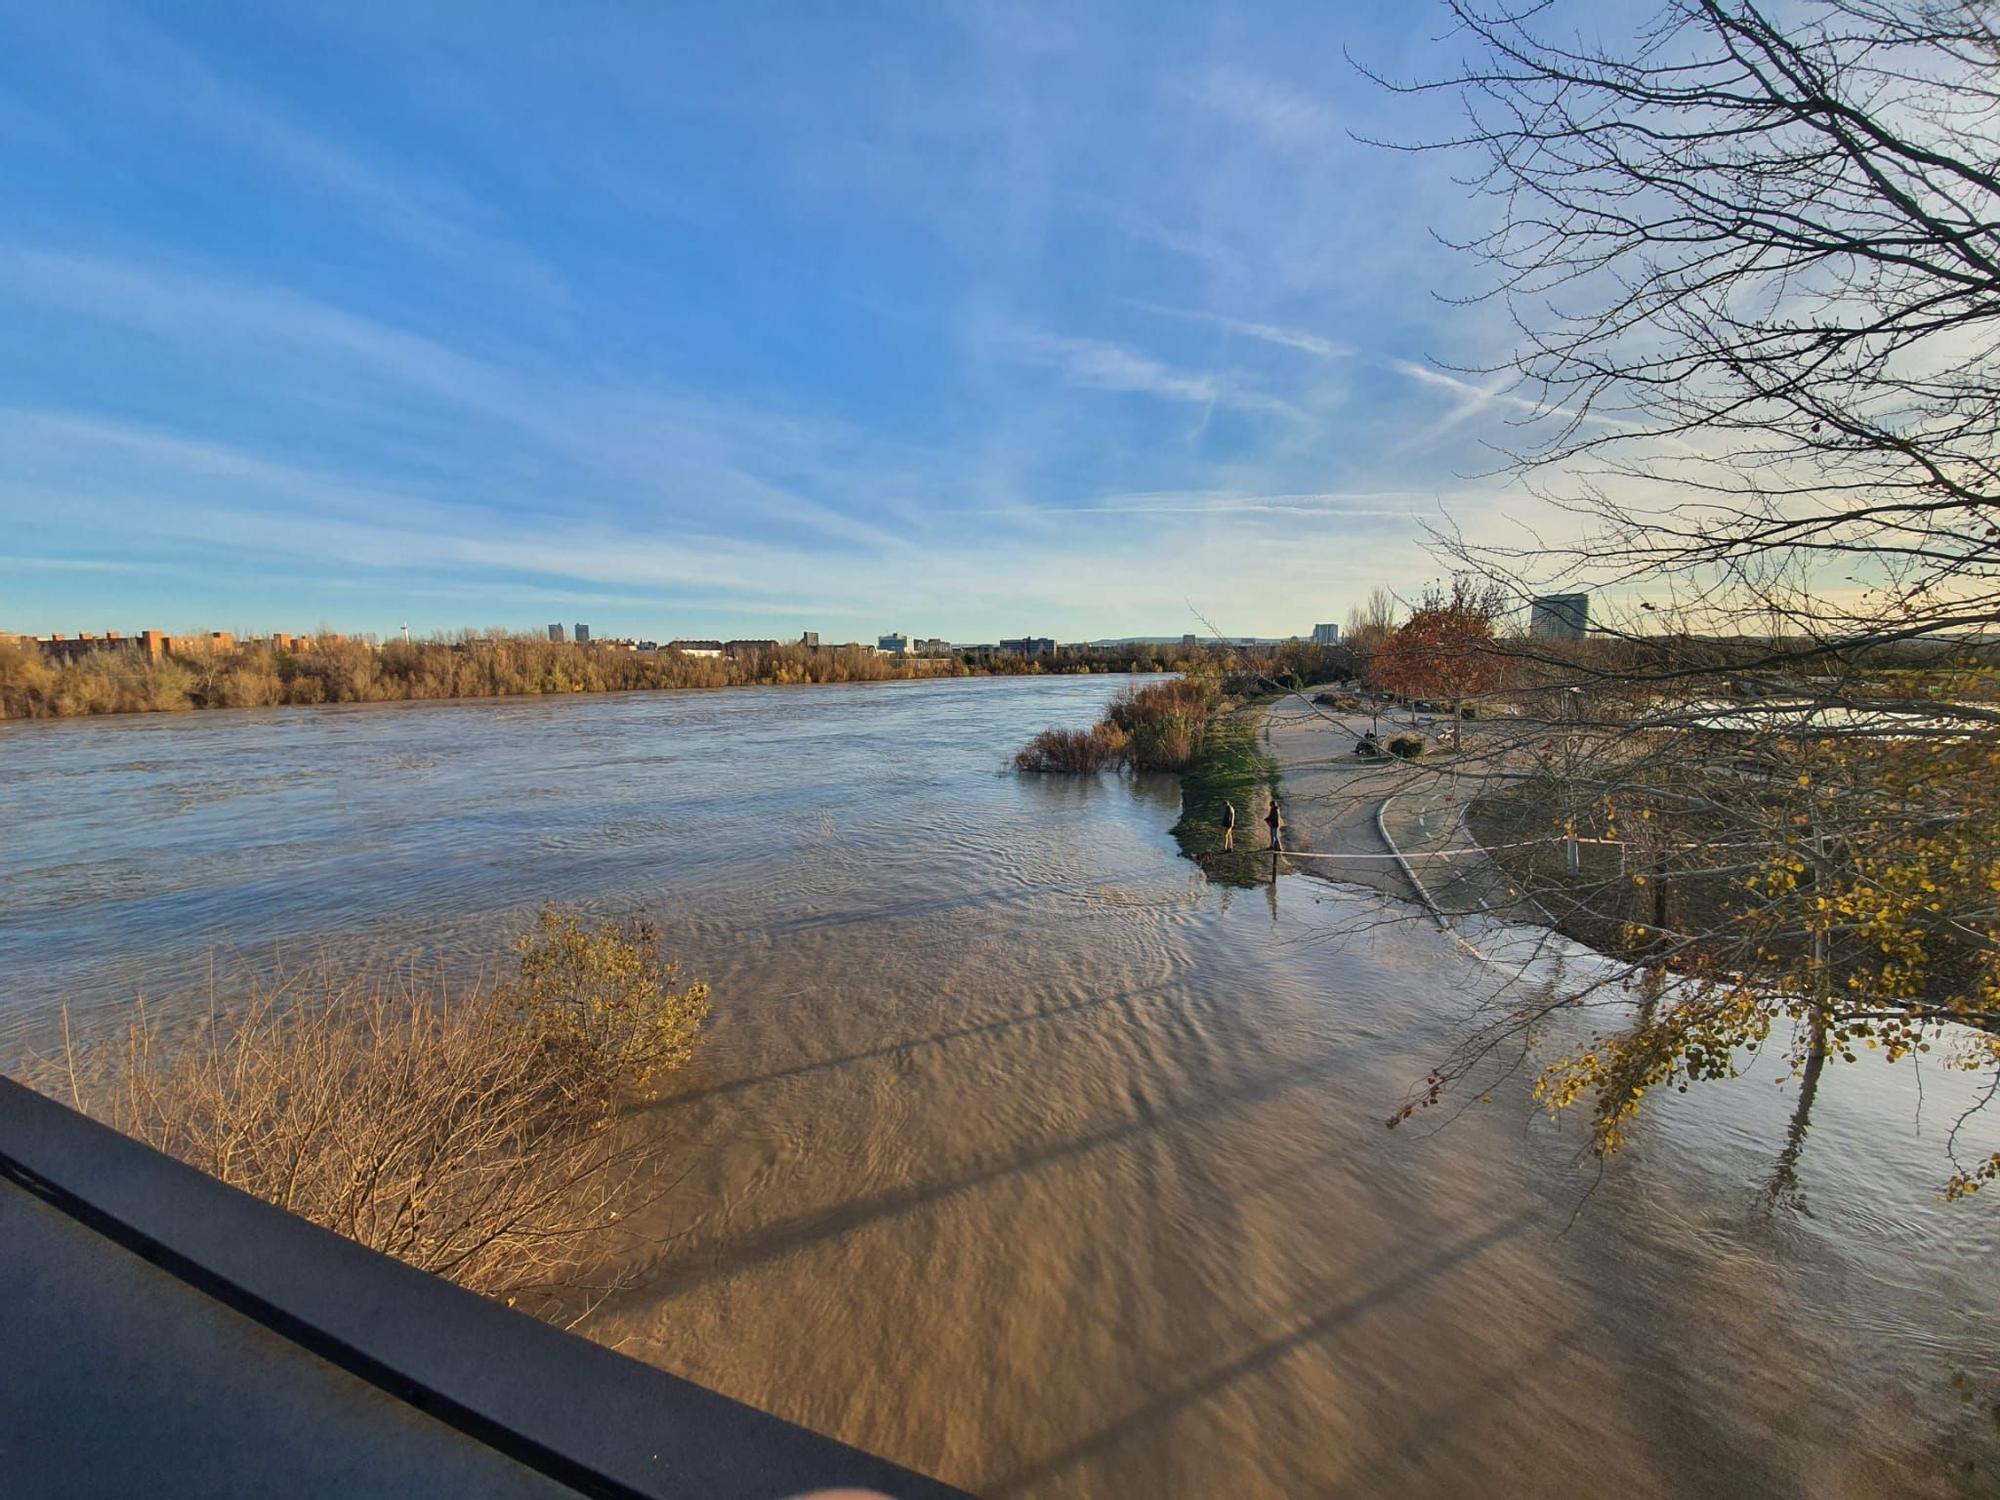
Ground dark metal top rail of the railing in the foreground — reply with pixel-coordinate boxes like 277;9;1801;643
0;1078;964;1500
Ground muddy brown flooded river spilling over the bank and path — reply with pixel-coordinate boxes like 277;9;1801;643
0;678;2000;1500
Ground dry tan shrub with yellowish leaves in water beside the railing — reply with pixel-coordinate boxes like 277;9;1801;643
38;912;708;1314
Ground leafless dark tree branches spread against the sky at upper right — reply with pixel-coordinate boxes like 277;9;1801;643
1368;0;2000;680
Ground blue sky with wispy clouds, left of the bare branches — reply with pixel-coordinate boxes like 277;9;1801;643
0;0;1576;640
